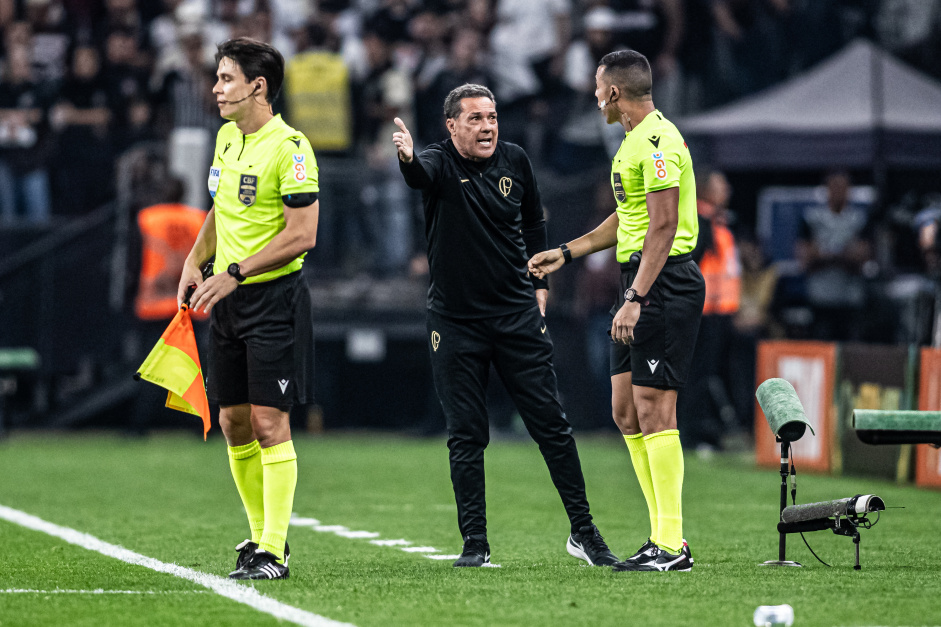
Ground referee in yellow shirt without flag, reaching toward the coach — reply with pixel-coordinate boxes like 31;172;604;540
529;50;706;571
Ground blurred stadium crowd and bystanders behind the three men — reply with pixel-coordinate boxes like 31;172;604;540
0;0;941;452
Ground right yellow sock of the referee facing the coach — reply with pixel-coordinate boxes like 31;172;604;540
644;429;683;553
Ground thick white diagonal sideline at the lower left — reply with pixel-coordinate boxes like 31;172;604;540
0;505;352;627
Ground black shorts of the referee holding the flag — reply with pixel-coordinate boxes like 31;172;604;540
206;272;314;410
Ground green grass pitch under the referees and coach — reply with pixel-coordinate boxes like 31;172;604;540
0;434;941;627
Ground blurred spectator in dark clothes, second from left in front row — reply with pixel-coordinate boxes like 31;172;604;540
50;46;117;214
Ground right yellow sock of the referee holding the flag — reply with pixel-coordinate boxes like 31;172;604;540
258;440;297;562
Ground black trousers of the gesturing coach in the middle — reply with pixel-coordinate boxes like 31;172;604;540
428;305;591;538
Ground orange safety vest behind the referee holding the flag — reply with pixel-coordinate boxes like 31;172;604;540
134;203;206;320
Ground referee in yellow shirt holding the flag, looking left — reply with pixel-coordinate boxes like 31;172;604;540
177;38;320;579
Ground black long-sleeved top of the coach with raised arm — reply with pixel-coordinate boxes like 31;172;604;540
399;139;547;318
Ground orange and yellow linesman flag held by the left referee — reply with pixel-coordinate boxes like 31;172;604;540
135;305;209;440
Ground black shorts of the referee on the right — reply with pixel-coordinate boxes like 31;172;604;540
610;252;706;389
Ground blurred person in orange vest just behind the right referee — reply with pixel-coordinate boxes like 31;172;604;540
676;166;741;449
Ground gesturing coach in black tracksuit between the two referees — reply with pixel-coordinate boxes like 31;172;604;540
392;85;617;567
